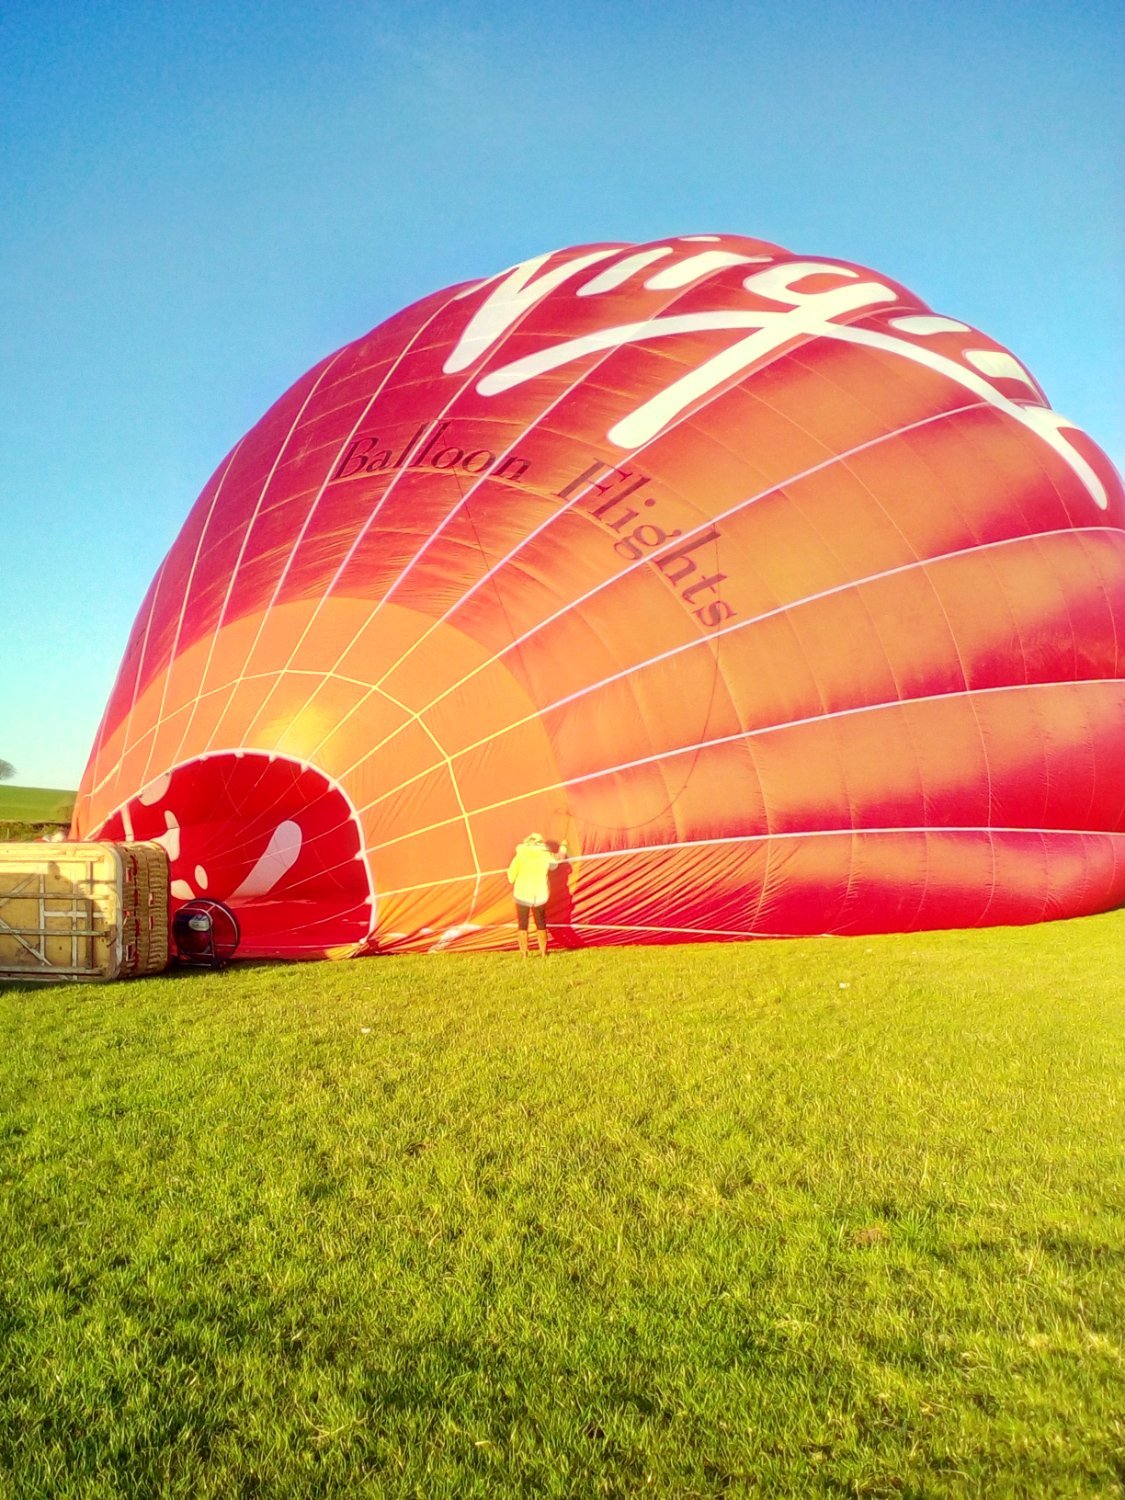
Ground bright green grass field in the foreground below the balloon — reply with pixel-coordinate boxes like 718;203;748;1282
0;914;1125;1500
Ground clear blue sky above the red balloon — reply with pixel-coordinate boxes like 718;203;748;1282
0;0;1125;788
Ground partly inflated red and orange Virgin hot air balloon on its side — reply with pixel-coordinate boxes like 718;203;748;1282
74;234;1125;957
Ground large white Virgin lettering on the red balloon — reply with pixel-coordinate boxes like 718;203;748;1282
444;246;1109;510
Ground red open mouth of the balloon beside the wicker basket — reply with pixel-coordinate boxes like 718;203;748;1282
98;750;375;959
